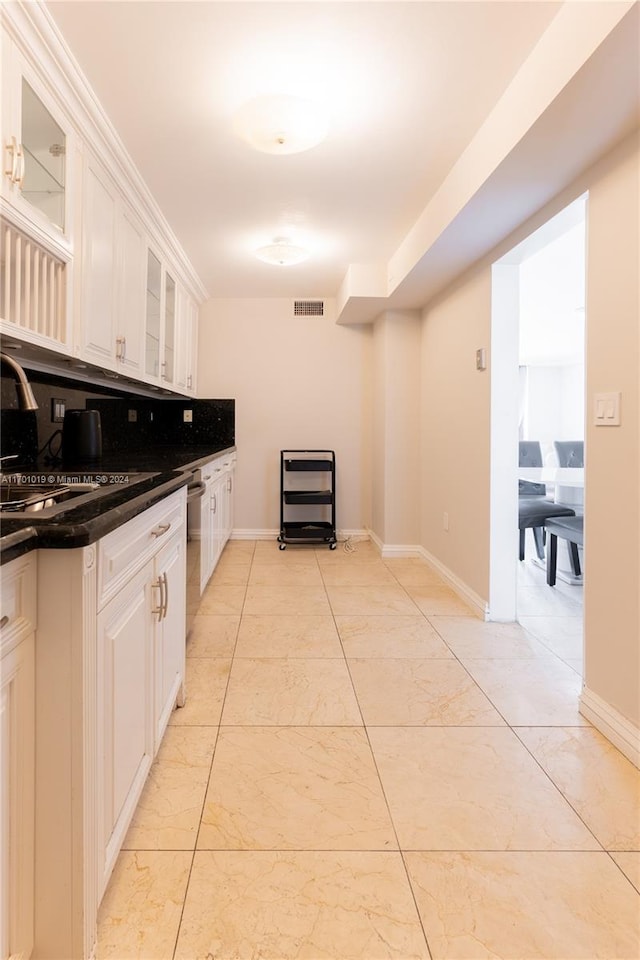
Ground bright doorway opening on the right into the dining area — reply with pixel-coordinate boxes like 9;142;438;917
489;194;587;671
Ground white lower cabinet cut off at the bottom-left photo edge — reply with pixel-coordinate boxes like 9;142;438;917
0;554;36;960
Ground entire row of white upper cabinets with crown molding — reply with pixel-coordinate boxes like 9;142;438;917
0;2;207;395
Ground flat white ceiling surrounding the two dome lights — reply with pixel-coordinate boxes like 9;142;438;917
47;0;561;297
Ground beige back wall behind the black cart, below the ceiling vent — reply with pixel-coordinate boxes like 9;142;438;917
198;299;372;531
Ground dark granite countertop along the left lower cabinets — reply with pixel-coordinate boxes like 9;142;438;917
0;446;236;564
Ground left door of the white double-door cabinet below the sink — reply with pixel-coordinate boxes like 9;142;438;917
98;564;153;883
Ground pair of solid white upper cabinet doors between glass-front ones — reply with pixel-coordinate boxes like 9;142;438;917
76;155;146;376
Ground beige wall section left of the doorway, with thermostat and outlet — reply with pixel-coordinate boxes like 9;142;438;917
420;266;491;599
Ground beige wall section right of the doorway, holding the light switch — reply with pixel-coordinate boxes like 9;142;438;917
585;131;640;727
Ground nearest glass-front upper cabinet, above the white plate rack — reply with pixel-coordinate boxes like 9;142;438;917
1;34;74;259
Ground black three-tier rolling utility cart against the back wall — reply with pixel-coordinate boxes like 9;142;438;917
278;450;338;550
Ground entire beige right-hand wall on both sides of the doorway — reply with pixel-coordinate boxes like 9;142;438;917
421;129;640;728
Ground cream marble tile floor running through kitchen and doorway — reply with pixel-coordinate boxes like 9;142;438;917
97;541;640;960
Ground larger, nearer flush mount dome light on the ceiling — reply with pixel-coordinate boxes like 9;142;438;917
234;95;329;154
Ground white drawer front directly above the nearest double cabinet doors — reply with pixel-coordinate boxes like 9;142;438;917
98;488;186;610
